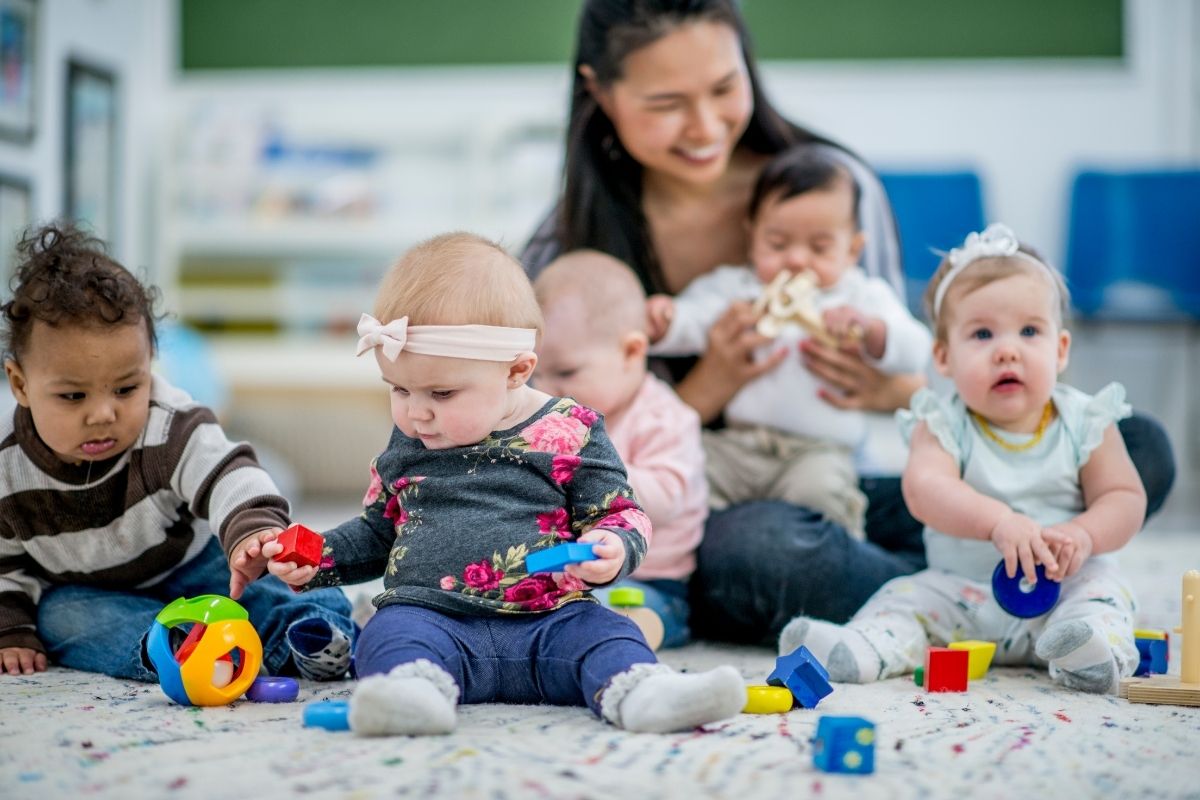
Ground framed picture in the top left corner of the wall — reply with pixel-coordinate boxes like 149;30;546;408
0;0;37;143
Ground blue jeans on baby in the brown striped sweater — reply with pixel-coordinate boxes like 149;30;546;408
37;537;354;681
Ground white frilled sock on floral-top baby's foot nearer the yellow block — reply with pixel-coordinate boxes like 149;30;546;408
600;664;746;733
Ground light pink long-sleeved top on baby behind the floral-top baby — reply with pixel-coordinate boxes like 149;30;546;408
605;374;708;581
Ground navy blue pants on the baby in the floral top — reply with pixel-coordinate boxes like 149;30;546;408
354;602;655;716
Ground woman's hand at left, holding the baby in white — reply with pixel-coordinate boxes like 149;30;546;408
676;301;788;422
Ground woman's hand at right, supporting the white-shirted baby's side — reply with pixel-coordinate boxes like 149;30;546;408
800;338;925;411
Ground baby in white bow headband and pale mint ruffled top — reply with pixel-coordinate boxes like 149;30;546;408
780;224;1146;692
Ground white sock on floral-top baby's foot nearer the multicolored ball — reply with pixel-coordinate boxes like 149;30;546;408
350;658;458;736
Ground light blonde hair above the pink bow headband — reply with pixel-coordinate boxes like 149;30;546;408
374;231;542;336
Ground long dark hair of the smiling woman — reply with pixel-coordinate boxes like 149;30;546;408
554;0;824;294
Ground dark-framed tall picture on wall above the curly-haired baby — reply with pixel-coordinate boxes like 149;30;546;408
62;60;120;248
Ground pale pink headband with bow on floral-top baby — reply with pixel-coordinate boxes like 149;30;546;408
355;314;538;361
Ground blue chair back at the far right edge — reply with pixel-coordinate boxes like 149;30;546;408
1063;169;1200;320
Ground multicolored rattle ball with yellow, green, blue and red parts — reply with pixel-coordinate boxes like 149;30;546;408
146;595;263;705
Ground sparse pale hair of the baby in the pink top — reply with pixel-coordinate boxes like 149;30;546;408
534;249;646;341
